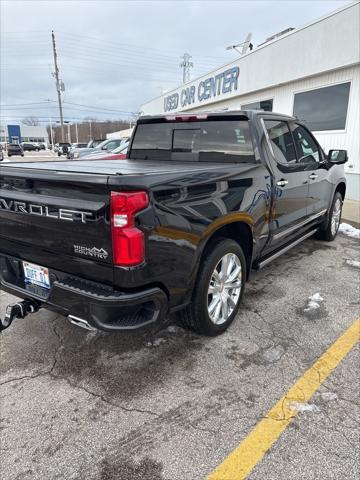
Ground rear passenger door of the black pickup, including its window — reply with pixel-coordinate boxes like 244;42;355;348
264;119;309;250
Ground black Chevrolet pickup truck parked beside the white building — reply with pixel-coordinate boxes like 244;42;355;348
0;111;347;335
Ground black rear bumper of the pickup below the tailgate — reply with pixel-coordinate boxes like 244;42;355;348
0;253;168;332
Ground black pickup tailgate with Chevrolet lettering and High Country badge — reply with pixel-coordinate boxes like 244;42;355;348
0;165;112;283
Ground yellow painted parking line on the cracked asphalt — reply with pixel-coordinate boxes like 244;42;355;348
208;318;360;480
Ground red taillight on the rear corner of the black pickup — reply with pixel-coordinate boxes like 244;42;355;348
110;191;149;267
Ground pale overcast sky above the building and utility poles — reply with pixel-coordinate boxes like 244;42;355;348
0;0;349;123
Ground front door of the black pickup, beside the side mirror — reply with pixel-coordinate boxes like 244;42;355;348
290;122;332;217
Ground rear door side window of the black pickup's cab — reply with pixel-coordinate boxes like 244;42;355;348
265;120;297;164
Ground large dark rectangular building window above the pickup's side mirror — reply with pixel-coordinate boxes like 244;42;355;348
294;82;350;132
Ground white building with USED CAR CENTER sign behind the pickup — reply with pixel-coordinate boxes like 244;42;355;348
141;1;360;200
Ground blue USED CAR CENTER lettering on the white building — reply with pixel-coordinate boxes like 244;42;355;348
164;67;239;112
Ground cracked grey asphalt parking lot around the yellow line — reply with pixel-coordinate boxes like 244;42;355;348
0;234;360;480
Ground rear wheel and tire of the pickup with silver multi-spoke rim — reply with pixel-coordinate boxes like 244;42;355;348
178;238;246;336
